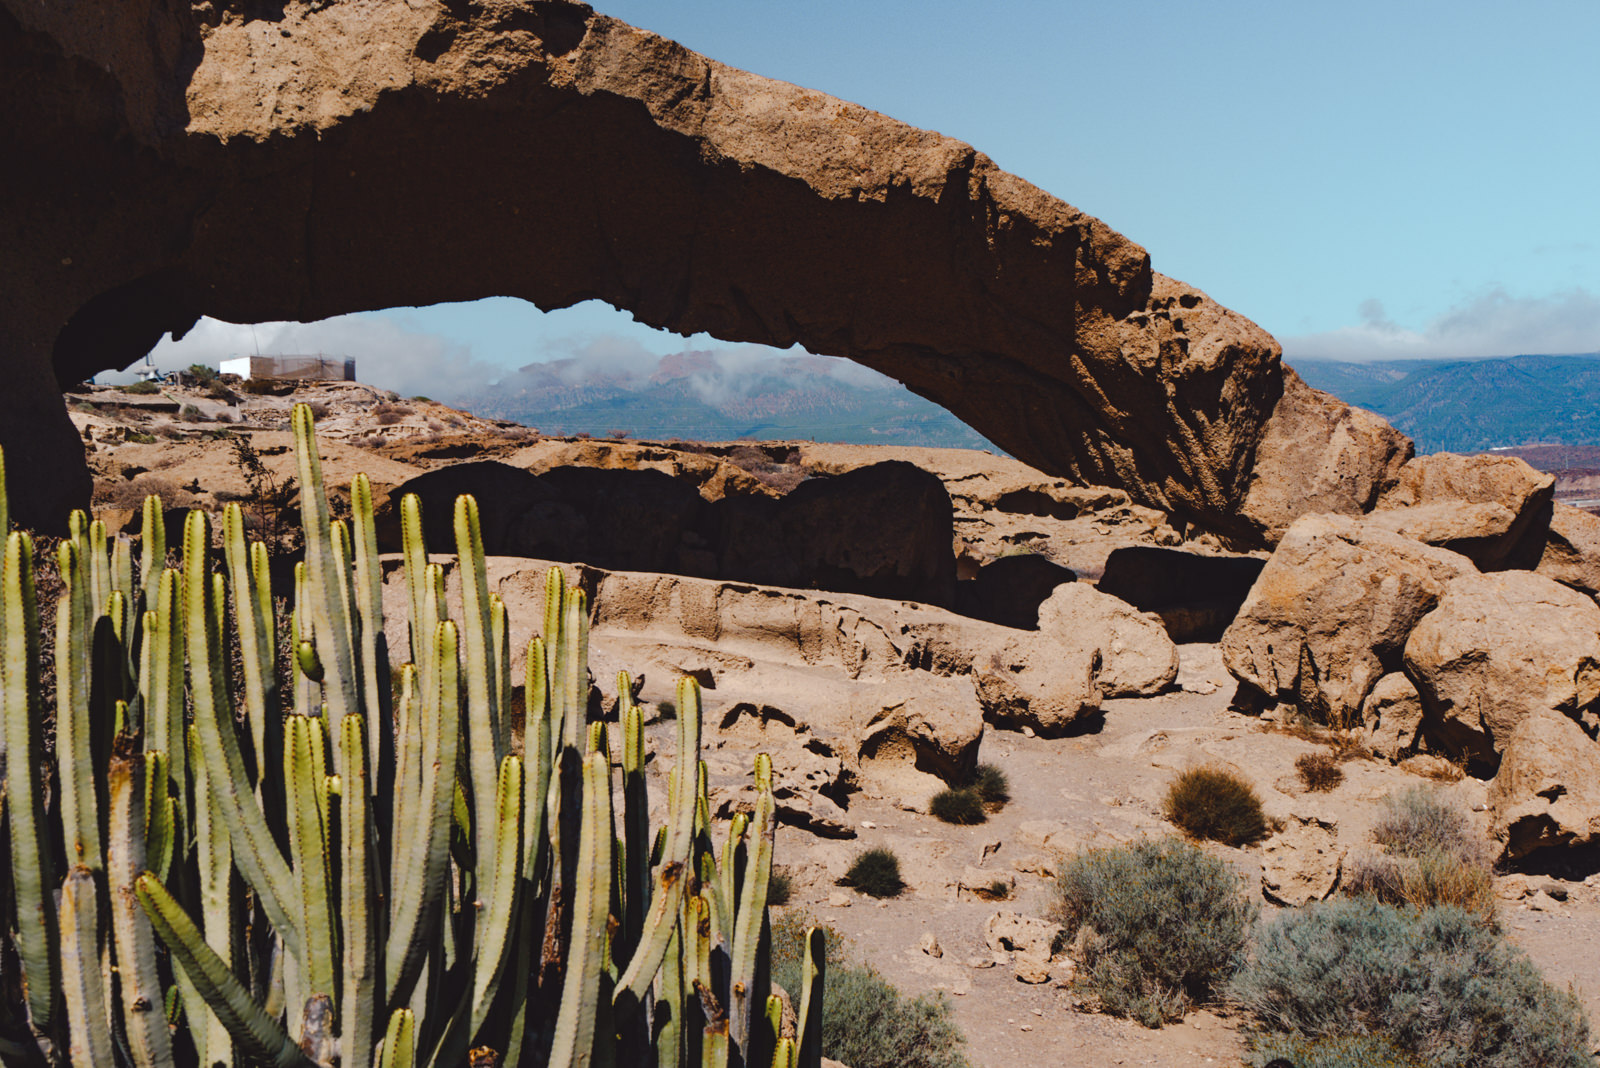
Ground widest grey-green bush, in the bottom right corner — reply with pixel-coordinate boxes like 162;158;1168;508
1232;899;1589;1068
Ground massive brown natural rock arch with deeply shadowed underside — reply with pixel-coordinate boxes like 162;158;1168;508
0;0;1411;534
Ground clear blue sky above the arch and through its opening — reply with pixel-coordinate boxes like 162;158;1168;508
158;0;1600;383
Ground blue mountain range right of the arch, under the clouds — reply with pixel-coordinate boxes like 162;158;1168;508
1291;353;1600;452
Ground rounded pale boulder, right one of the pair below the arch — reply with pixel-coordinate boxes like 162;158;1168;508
1038;582;1178;697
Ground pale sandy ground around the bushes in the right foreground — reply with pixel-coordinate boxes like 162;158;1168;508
778;646;1600;1068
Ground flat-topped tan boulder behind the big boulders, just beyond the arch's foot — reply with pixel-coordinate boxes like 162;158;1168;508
1368;452;1555;571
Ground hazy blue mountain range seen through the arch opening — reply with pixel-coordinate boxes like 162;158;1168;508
451;349;995;449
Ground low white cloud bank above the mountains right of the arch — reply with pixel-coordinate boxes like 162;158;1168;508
1283;289;1600;361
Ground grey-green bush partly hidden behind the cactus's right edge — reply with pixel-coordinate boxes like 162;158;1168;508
773;913;970;1068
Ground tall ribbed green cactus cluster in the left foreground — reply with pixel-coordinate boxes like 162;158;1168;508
0;404;824;1068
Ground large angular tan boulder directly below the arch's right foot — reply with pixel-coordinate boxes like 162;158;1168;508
1222;515;1474;724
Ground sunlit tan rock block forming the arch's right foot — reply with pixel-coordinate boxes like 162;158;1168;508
1240;368;1416;545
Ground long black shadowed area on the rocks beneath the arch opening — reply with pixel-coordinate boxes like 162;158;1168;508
379;460;955;606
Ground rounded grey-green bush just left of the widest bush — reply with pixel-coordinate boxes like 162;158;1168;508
1053;838;1256;1026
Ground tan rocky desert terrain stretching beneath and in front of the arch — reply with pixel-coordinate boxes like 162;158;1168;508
67;381;1600;1068
